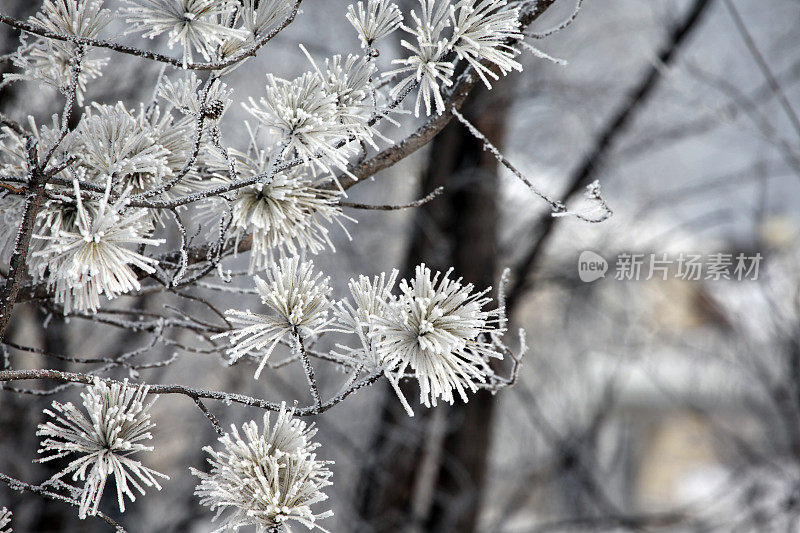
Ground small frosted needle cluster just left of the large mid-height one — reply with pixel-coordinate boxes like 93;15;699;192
212;257;333;379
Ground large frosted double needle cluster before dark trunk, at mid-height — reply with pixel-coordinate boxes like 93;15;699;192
336;264;505;416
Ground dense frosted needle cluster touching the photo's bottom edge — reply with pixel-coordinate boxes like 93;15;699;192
191;404;333;533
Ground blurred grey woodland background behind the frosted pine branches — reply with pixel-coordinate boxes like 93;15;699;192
0;0;800;533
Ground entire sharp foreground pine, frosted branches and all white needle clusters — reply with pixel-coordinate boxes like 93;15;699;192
0;0;556;532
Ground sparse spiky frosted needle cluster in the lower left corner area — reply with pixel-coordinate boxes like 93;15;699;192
36;379;169;518
